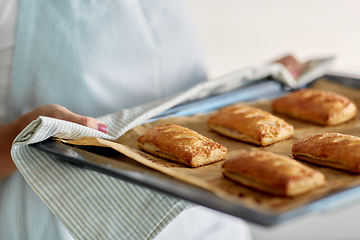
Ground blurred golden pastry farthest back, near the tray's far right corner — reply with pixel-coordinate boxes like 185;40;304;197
272;89;357;125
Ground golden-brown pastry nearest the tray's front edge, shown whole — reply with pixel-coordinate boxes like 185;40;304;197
222;151;325;196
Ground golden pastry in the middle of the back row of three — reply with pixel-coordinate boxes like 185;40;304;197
208;107;294;146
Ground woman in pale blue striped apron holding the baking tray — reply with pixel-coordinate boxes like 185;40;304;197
0;0;297;239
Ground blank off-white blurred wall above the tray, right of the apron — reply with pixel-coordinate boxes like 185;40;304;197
186;0;360;77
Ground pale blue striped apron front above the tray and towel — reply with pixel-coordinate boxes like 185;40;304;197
7;0;206;121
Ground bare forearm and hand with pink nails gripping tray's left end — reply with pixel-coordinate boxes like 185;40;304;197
0;105;107;180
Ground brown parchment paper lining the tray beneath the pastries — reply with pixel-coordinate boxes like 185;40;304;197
66;79;360;213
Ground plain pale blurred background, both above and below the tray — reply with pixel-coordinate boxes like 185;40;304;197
186;0;360;240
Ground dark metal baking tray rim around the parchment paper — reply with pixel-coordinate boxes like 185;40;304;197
30;75;360;226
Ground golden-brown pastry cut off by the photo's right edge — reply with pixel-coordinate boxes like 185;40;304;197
292;133;360;173
